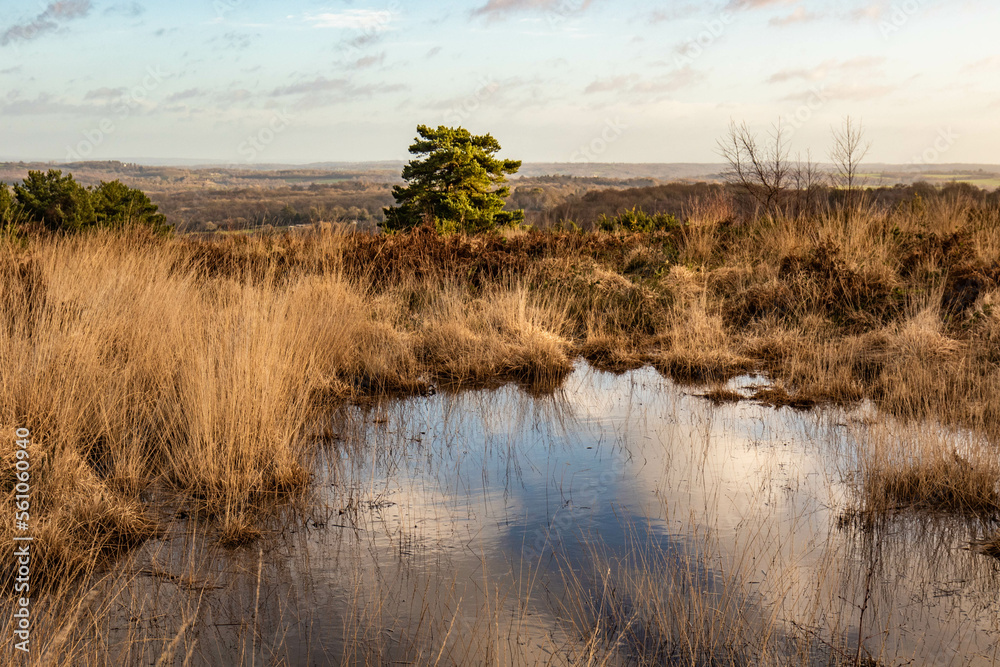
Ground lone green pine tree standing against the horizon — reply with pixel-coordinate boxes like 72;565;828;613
383;125;524;234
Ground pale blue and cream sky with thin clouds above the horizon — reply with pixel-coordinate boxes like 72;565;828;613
0;0;1000;165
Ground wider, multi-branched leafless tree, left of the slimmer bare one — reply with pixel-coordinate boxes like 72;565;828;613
718;121;789;215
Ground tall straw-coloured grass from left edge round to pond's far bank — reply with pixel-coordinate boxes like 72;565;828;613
0;226;570;596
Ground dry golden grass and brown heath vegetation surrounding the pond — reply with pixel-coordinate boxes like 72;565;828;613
0;185;1000;660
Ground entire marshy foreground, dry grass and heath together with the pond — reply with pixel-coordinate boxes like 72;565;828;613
0;190;1000;665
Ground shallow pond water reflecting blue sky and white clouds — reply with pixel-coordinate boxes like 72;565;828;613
107;366;1000;665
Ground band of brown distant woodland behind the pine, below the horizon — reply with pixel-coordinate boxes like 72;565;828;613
155;176;1000;231
